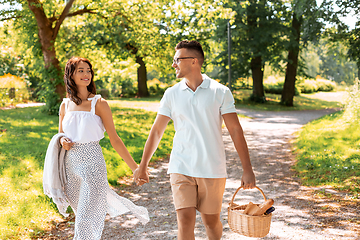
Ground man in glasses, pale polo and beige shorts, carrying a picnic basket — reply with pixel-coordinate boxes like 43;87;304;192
134;41;255;240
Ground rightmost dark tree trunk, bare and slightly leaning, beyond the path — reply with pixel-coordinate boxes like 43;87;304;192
281;13;302;107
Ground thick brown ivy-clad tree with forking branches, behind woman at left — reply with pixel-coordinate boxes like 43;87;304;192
0;0;98;112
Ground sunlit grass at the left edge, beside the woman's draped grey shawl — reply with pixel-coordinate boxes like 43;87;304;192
0;108;58;239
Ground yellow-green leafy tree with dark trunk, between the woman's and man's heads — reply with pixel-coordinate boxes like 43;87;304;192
89;1;174;97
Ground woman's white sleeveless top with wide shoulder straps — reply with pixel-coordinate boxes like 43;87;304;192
62;95;105;143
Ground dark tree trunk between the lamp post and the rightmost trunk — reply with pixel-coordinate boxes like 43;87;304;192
250;56;265;102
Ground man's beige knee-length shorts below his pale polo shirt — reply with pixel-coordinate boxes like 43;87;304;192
170;173;226;214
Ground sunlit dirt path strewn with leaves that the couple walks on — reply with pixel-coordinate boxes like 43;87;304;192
46;104;360;240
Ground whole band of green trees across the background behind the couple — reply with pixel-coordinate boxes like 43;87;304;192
0;0;360;110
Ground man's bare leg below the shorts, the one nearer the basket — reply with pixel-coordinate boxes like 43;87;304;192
201;213;223;240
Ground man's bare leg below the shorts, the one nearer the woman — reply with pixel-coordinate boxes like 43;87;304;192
176;207;196;240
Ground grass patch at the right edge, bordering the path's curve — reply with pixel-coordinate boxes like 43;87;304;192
294;111;360;198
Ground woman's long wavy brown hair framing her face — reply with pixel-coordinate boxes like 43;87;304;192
64;57;96;105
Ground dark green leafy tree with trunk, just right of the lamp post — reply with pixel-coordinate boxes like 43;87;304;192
216;0;285;102
